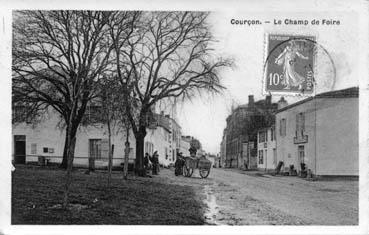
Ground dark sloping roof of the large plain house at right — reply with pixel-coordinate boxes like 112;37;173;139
276;87;359;113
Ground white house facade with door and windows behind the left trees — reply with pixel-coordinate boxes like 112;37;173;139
12;110;136;168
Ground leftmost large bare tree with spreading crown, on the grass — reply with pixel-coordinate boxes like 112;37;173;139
12;11;112;205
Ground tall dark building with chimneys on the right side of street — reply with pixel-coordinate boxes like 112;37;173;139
223;95;278;169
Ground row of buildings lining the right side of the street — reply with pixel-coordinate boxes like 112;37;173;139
220;87;359;176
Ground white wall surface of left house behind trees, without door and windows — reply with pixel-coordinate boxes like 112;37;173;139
12;111;135;167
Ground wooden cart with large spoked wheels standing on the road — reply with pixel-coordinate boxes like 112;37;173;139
183;157;211;178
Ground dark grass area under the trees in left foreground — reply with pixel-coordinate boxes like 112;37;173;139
11;166;205;225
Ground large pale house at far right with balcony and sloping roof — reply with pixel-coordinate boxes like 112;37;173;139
276;87;359;176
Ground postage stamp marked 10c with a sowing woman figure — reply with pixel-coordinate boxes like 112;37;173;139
263;34;317;95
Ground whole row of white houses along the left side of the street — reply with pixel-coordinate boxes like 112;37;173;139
12;107;201;168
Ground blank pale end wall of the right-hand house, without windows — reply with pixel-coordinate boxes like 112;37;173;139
316;98;359;175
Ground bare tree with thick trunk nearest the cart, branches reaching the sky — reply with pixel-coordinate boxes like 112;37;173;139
111;12;232;175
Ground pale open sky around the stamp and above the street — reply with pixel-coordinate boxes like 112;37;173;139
177;11;360;153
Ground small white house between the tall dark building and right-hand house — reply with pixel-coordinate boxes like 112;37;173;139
257;125;277;171
